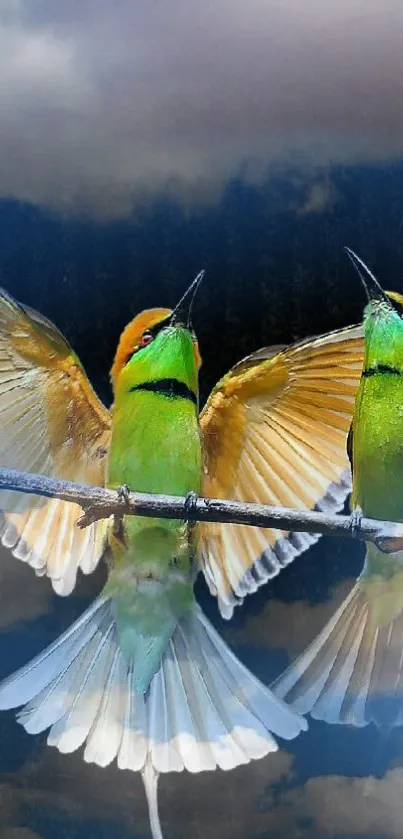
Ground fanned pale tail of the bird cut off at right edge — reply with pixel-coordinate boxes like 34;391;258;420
271;577;403;726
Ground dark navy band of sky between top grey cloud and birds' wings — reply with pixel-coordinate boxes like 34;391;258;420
0;162;403;406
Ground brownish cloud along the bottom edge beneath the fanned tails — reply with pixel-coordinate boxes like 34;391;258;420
6;749;403;839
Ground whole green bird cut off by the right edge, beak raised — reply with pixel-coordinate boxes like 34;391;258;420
272;251;403;726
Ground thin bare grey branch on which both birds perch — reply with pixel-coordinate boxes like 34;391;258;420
0;469;403;553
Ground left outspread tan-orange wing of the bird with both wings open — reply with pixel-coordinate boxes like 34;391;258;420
0;291;110;594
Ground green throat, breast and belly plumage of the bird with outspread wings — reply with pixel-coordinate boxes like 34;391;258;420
106;326;202;693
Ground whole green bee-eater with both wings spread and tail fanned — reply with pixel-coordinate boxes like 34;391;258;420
0;274;362;836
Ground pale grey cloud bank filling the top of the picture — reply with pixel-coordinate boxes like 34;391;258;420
0;0;403;216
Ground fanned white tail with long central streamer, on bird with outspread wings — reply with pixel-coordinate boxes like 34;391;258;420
0;598;307;839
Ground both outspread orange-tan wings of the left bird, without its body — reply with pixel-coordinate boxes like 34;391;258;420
0;286;362;616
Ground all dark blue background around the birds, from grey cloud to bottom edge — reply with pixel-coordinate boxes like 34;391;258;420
0;162;403;839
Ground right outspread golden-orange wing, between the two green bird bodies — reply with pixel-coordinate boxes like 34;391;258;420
200;326;364;617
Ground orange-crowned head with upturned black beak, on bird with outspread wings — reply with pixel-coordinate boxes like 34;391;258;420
111;273;203;395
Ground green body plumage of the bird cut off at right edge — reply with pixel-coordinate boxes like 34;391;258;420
352;300;403;626
